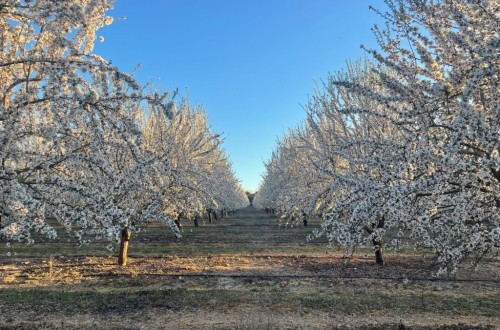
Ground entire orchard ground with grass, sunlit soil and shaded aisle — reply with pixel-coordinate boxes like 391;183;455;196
0;207;500;330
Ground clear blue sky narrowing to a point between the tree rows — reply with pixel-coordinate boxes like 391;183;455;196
94;0;384;191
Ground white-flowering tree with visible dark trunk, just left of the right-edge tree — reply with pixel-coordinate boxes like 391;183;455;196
307;61;405;264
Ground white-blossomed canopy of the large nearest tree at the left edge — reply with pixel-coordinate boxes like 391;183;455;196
0;0;180;251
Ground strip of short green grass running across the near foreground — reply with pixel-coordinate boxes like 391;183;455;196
0;281;500;317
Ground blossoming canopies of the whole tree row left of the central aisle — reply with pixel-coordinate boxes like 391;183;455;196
0;0;248;250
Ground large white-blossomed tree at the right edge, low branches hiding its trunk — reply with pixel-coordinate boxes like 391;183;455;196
324;0;500;271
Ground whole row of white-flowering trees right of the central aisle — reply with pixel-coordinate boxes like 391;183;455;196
254;0;500;272
